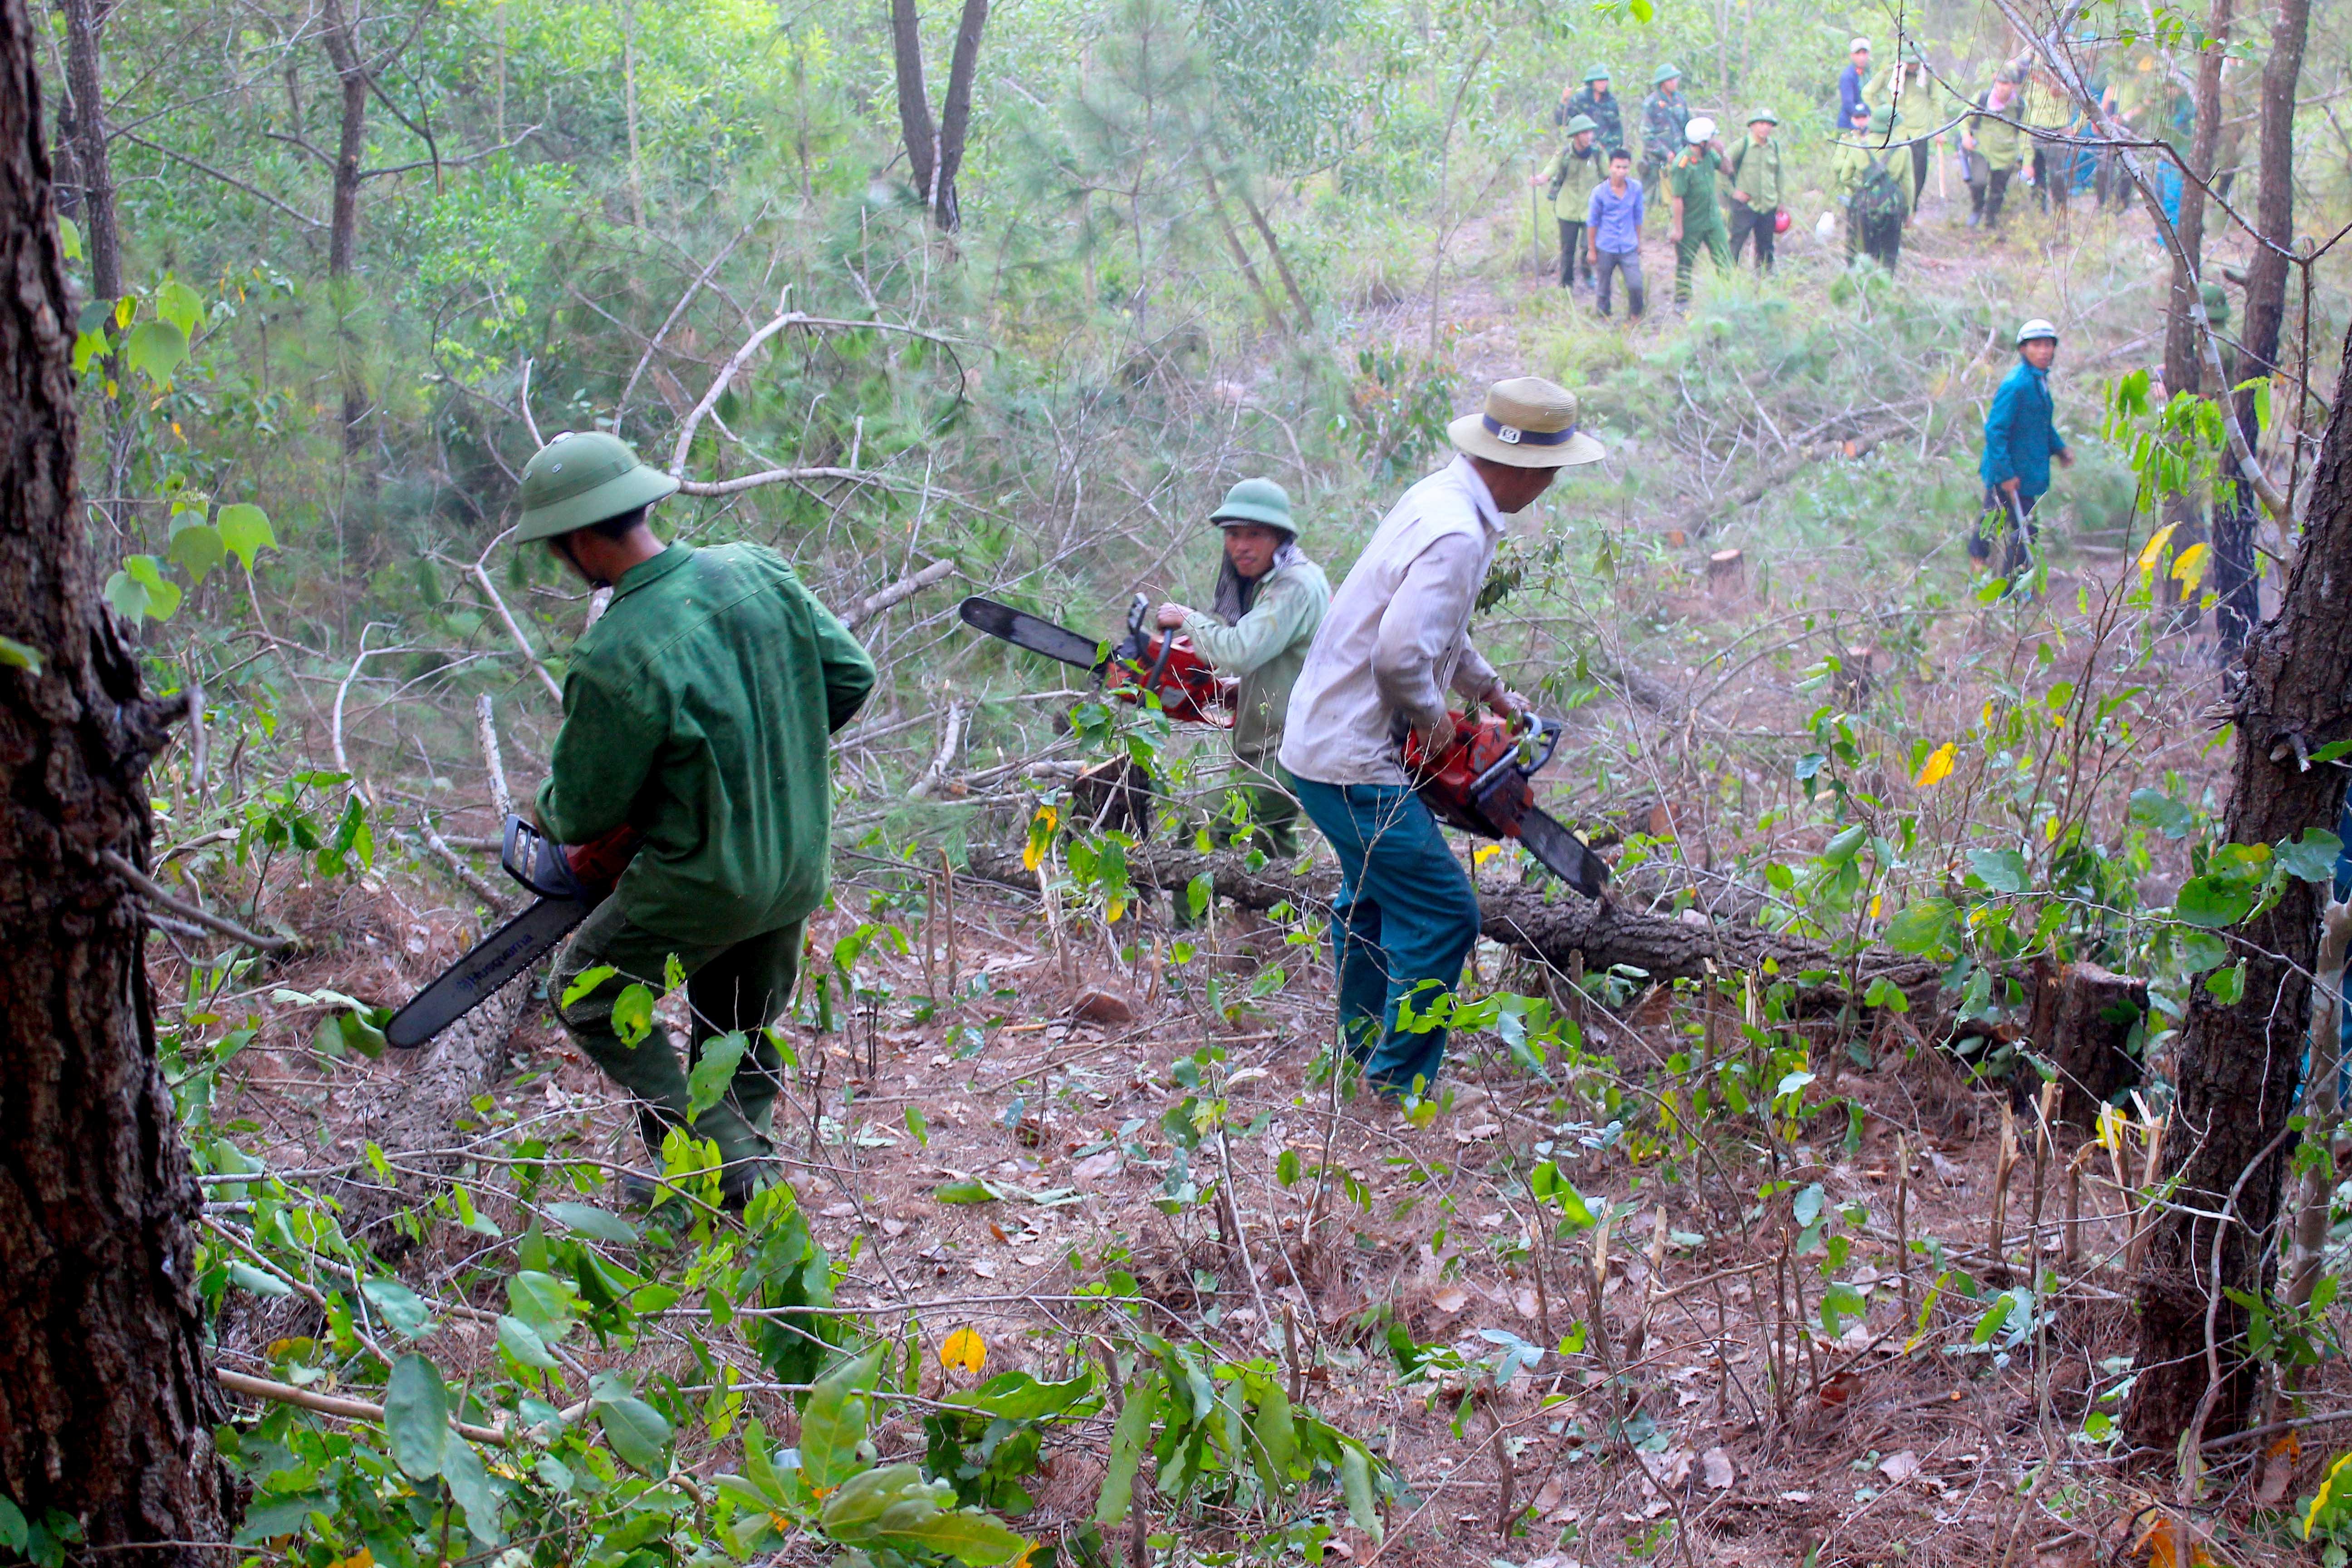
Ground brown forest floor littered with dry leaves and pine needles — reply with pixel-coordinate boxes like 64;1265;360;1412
165;162;2323;1568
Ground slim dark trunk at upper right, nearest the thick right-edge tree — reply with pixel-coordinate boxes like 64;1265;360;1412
2213;0;2312;653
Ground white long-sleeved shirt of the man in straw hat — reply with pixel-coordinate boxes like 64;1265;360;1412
1282;456;1505;785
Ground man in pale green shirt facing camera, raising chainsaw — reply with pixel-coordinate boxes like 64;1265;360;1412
1160;480;1331;860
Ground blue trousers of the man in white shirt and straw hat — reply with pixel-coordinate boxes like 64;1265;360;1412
1294;778;1477;1096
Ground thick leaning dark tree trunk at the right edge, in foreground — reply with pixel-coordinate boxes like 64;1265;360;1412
2126;313;2352;1450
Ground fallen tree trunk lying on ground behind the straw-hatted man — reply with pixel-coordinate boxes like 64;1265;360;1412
967;844;1943;1032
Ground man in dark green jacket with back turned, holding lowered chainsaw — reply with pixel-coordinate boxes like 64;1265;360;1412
515;430;875;1206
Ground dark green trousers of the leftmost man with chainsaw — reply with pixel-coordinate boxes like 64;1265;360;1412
548;898;804;1164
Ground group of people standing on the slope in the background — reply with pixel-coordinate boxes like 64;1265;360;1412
1534;38;2192;317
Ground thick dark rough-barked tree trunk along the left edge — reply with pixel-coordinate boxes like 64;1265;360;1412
0;0;228;1568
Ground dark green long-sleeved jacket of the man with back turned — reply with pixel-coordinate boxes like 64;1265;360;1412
539;545;875;943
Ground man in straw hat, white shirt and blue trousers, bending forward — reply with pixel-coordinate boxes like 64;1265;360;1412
1282;376;1607;1096
